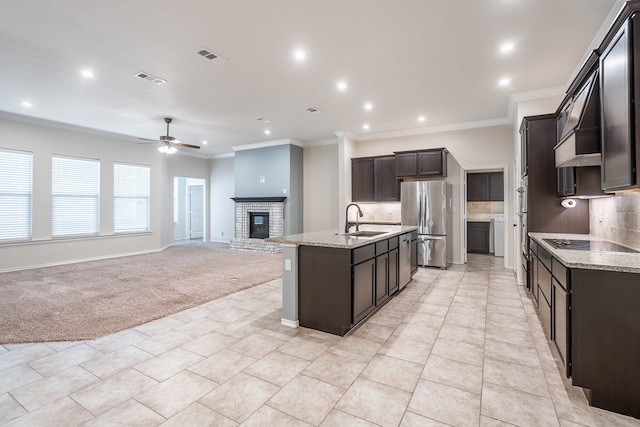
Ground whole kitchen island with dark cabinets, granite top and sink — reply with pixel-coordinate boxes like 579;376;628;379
268;225;417;336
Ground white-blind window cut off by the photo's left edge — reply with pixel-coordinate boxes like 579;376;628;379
0;150;33;242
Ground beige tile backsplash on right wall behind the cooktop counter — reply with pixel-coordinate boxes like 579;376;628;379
589;192;640;250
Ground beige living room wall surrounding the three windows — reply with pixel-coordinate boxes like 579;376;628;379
0;116;207;271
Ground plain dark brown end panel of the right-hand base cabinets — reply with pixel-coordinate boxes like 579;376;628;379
569;269;640;418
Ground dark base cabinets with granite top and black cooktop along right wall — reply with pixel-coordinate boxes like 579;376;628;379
528;233;640;418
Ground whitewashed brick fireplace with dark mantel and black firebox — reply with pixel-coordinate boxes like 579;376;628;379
230;197;286;253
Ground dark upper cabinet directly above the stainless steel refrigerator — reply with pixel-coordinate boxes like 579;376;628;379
395;148;448;178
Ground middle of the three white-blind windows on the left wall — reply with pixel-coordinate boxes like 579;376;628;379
51;156;100;237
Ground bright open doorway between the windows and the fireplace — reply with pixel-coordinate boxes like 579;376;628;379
173;177;205;241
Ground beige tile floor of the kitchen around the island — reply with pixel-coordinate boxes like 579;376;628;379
0;256;640;426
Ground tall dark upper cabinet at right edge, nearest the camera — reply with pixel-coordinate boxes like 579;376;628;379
600;14;640;191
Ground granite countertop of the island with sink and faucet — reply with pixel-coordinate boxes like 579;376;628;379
267;224;418;249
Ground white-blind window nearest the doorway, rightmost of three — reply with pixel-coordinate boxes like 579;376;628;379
113;163;150;233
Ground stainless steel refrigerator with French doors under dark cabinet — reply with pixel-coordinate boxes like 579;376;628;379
400;180;453;268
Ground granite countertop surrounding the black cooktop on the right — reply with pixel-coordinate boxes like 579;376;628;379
529;233;640;273
